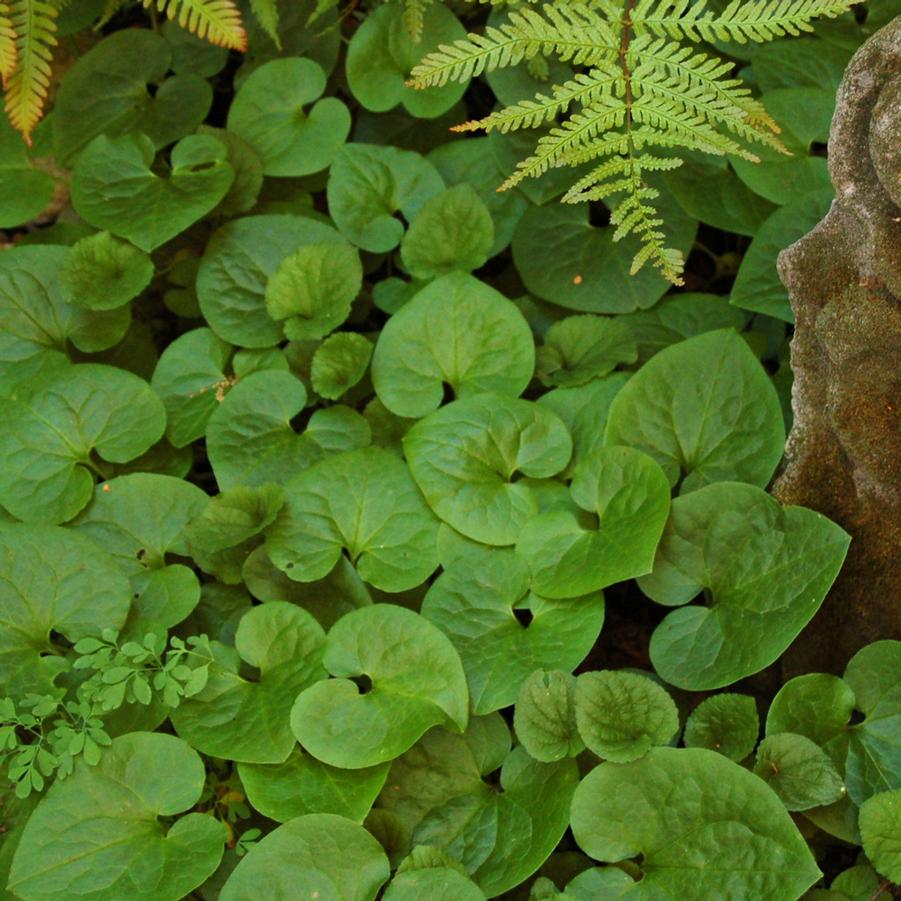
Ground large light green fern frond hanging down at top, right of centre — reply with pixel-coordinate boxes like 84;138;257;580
410;0;858;284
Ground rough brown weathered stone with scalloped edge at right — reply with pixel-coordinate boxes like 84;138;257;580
774;18;901;675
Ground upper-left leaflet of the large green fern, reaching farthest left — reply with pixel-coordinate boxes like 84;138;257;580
407;2;619;88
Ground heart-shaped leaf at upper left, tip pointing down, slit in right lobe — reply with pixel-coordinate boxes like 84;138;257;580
72;134;235;253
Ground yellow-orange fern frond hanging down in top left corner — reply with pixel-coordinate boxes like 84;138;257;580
4;0;57;144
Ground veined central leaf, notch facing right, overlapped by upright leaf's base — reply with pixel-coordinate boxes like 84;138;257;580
404;393;572;545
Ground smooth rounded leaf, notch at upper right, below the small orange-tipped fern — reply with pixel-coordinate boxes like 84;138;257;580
228;58;350;176
